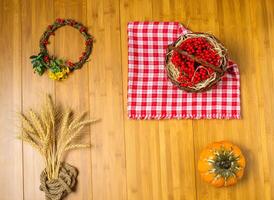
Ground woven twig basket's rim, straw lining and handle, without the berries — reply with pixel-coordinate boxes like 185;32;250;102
165;32;227;92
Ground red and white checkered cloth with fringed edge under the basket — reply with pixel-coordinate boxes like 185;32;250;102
127;22;240;119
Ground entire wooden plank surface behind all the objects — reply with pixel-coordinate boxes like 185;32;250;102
0;0;274;200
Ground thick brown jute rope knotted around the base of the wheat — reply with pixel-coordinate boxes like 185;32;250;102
40;163;78;200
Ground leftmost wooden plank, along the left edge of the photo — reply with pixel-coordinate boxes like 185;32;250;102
0;0;23;200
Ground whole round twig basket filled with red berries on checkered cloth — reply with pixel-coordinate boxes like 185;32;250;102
166;33;227;92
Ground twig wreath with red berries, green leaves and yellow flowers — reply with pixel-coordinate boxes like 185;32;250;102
30;18;93;80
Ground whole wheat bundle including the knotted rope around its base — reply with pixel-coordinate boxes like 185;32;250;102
18;95;95;200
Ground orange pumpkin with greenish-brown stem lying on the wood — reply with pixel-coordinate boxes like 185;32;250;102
198;141;246;187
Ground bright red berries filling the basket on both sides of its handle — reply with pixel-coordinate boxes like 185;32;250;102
171;37;220;87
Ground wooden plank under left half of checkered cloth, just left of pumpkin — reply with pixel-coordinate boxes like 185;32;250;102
121;1;196;199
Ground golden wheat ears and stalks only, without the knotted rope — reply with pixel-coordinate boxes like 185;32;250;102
18;95;94;180
